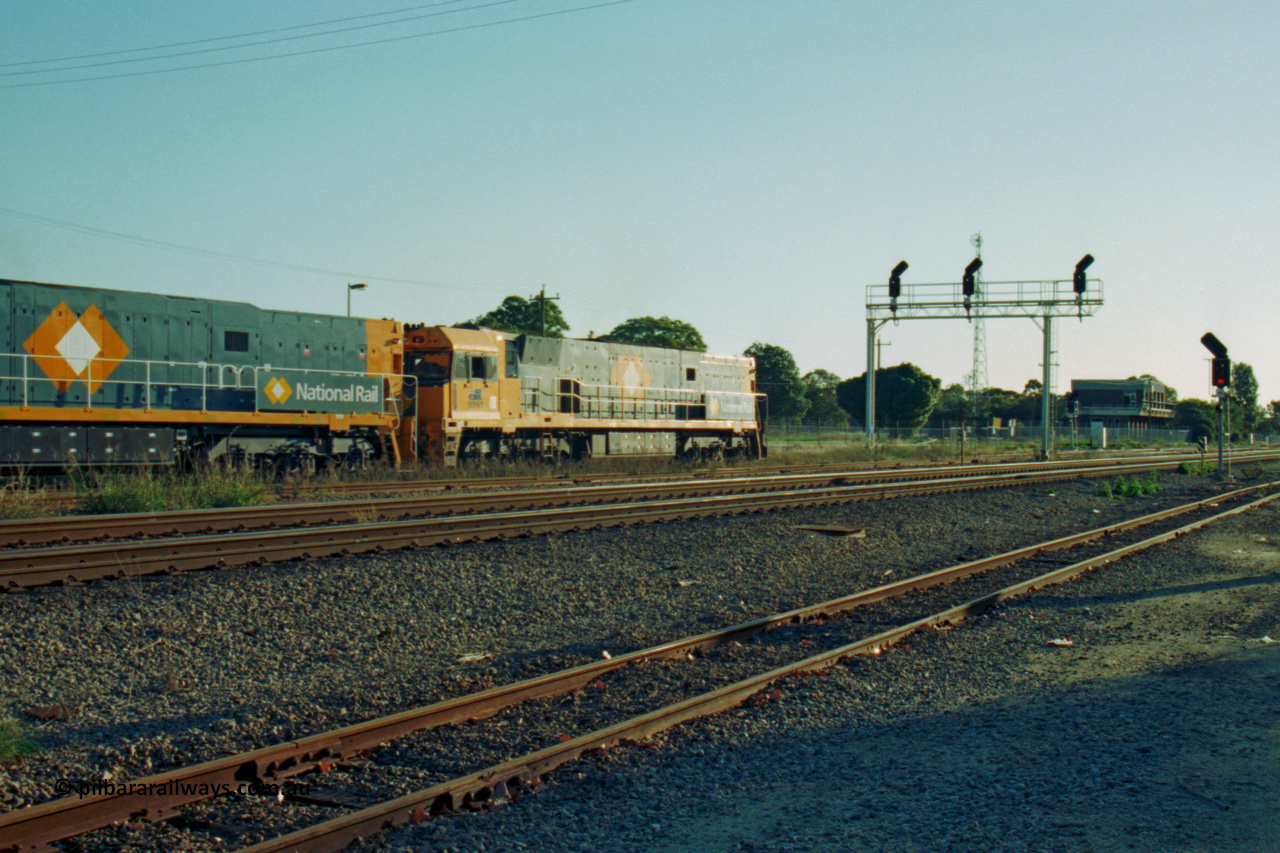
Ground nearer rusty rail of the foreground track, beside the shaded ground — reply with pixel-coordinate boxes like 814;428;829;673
239;484;1280;853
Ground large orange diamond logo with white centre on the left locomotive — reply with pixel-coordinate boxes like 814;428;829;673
22;302;129;393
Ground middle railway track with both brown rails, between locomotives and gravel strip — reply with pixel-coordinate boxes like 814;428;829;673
0;460;1274;590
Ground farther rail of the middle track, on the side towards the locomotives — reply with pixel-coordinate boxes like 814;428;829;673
0;453;1280;547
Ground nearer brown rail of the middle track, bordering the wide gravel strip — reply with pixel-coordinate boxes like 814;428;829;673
0;455;1228;589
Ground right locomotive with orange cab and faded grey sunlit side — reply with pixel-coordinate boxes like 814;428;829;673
410;327;763;465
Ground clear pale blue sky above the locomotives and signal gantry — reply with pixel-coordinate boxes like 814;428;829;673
0;0;1280;402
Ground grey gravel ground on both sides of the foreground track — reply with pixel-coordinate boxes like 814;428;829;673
0;468;1280;850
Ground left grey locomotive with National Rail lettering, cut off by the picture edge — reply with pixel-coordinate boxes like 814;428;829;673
0;280;412;462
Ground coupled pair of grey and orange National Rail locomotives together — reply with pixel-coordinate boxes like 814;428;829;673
0;280;765;469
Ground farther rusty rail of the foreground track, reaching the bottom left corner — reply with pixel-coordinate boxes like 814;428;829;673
0;484;1277;853
